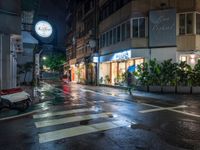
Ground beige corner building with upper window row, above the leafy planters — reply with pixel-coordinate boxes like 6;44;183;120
99;0;200;84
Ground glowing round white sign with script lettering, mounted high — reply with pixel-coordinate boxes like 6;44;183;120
35;21;53;38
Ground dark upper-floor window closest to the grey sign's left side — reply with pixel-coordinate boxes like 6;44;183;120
132;18;145;38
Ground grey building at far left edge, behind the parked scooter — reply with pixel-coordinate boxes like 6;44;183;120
0;0;22;89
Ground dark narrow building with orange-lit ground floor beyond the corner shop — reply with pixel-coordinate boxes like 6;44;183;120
67;0;98;84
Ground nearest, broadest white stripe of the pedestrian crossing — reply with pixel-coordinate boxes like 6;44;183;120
39;121;126;143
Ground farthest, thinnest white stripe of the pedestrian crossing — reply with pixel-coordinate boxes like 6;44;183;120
33;108;94;119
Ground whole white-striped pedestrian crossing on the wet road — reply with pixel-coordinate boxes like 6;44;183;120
33;103;127;143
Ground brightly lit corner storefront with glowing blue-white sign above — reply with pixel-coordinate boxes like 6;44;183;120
99;50;144;85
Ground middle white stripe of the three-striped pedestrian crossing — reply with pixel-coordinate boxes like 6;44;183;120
35;113;112;128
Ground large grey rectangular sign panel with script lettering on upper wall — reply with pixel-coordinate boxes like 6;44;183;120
149;9;176;47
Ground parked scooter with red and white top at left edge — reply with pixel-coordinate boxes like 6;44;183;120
0;88;32;111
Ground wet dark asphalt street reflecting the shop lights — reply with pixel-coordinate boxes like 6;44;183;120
0;84;200;150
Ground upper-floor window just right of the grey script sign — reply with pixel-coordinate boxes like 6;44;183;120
179;13;194;35
